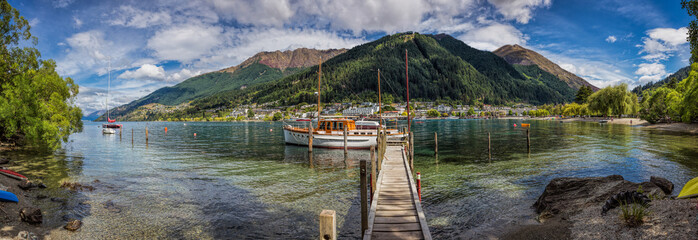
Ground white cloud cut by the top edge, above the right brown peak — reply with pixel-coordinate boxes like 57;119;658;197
487;0;552;24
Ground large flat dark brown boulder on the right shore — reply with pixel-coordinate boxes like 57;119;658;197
533;175;665;214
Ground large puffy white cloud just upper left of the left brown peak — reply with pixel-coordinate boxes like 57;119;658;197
147;25;223;63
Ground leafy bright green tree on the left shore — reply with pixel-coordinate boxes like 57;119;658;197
0;0;82;150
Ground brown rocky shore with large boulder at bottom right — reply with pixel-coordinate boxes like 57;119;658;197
499;175;698;239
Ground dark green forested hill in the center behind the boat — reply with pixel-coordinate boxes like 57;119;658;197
193;33;574;109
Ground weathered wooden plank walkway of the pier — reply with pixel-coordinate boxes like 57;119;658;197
364;145;431;240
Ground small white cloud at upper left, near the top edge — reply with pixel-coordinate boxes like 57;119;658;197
109;6;172;28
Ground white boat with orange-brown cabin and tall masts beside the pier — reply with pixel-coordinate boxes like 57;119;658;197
283;55;409;149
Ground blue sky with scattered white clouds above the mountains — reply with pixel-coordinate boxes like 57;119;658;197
9;0;691;115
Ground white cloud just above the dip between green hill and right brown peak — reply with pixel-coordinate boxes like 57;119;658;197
457;23;528;51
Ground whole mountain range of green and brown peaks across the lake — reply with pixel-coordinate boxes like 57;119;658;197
100;32;597;120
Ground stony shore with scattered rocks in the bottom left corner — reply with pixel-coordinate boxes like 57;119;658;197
0;157;81;239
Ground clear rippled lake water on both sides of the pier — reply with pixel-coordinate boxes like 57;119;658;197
2;120;698;239
